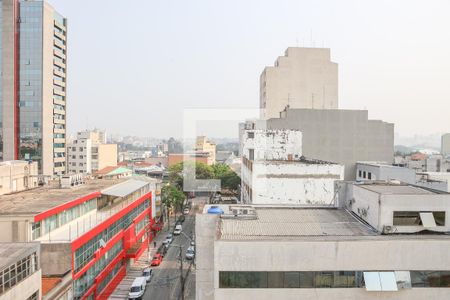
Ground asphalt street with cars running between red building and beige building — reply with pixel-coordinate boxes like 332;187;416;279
143;199;199;300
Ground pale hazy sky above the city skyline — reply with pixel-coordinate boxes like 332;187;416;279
49;0;450;137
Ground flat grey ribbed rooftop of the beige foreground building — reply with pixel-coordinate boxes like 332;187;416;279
220;206;377;240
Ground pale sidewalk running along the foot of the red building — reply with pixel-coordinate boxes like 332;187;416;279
109;223;171;300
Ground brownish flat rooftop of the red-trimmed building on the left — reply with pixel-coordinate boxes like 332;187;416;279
0;179;124;216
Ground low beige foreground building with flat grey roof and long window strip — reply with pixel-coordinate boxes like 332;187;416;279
196;200;450;300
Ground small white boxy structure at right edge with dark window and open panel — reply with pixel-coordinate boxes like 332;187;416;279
337;181;450;234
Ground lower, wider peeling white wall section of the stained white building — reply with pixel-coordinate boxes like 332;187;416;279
251;161;344;205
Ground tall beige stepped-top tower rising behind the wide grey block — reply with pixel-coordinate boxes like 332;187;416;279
260;47;338;119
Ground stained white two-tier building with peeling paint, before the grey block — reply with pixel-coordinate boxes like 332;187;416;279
241;130;344;205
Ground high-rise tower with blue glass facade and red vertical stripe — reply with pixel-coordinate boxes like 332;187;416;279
0;0;67;175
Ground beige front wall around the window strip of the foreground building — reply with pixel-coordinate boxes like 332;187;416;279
214;237;450;300
